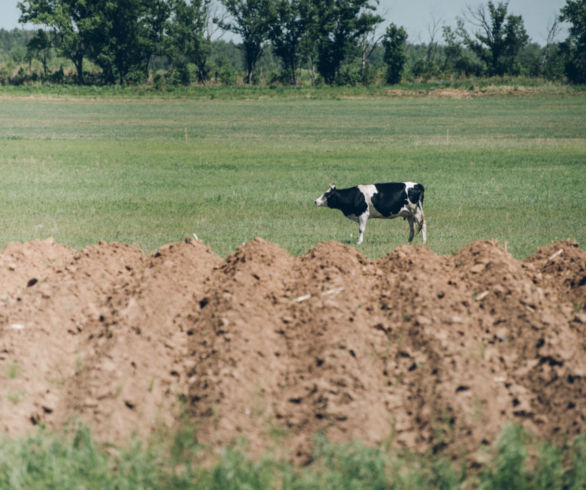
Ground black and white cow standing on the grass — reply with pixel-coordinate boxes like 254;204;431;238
315;182;427;245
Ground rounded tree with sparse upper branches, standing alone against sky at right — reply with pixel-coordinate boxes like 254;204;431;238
456;1;529;75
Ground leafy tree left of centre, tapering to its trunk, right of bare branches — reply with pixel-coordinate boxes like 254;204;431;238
214;0;270;83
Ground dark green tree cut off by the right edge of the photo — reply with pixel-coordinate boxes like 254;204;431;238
560;0;586;83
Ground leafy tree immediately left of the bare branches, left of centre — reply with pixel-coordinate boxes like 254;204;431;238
166;0;212;83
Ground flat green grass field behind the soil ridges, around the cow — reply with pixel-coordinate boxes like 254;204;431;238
0;88;586;257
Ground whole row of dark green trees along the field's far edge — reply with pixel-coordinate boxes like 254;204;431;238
5;0;586;85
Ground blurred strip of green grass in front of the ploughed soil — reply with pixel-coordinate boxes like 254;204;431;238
0;424;586;490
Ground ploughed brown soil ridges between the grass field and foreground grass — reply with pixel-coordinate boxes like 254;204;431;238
0;239;586;462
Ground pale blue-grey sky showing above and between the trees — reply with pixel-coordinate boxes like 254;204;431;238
0;0;566;45
